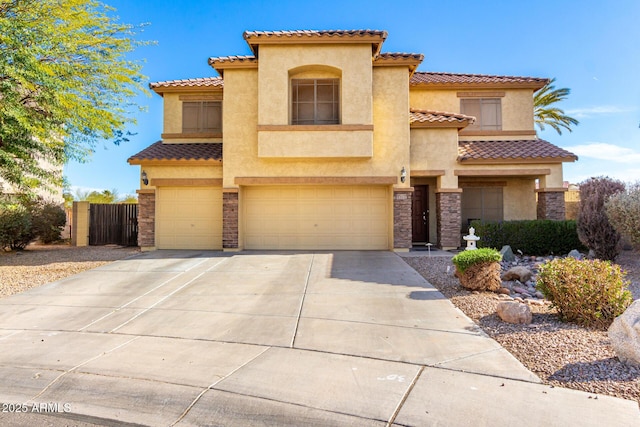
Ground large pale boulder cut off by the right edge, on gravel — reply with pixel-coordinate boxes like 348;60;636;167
608;300;640;366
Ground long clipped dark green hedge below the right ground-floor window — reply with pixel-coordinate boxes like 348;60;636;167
471;220;586;255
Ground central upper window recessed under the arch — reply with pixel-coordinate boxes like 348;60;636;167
291;79;340;125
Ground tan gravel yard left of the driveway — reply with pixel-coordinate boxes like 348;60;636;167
0;244;140;298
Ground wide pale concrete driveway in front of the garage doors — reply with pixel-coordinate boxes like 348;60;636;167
0;251;640;426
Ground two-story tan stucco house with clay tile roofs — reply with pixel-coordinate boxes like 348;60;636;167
129;30;576;251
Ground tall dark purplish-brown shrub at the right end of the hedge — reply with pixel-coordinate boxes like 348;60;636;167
577;177;625;261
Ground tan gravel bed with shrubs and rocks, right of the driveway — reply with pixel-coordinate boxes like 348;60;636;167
404;251;640;403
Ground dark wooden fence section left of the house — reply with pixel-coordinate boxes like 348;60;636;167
89;203;138;246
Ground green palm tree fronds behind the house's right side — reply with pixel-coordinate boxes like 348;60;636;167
533;78;580;135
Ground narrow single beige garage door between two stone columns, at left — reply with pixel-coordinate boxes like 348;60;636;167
156;187;222;249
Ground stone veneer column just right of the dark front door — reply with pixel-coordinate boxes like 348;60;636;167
436;190;462;249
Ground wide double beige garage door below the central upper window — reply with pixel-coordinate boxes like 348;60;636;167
242;186;391;250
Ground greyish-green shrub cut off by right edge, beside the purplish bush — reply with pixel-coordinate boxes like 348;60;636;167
604;182;640;249
